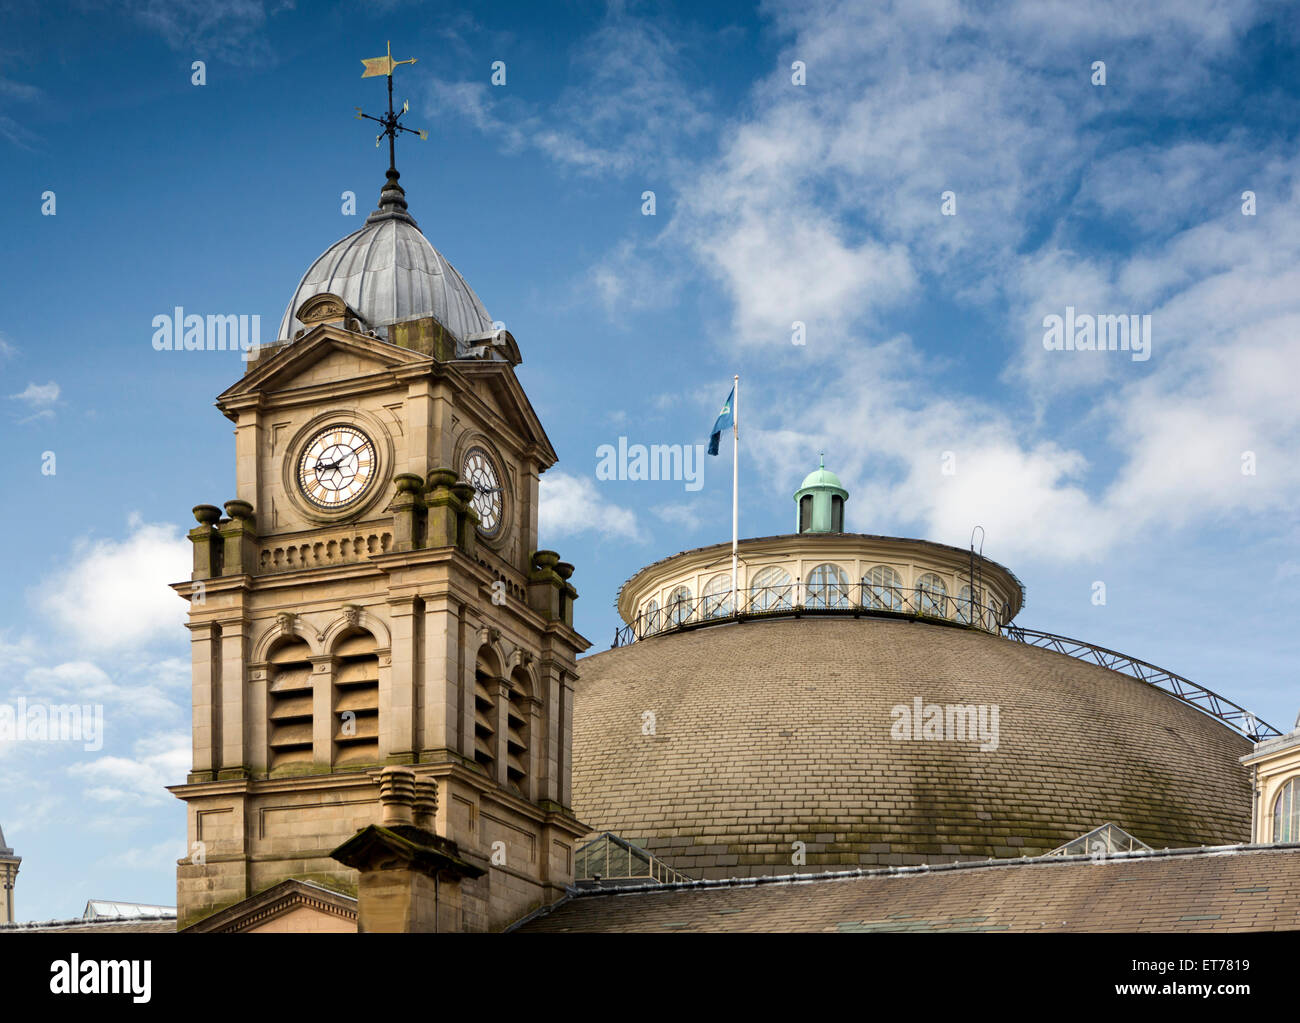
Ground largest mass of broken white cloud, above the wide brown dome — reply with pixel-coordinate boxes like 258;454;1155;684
553;0;1300;559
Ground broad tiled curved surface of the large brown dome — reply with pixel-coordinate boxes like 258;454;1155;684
573;617;1251;877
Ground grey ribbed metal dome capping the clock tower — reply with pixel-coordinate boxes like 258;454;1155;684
280;174;491;341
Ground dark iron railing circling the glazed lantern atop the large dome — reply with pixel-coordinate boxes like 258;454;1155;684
612;582;1010;646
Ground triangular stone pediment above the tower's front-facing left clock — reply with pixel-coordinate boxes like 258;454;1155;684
217;323;433;415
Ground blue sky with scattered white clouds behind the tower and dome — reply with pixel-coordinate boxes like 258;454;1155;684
0;0;1300;919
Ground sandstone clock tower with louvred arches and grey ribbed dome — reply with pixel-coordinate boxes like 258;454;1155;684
170;169;589;931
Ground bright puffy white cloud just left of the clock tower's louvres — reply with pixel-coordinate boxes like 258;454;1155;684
36;517;192;650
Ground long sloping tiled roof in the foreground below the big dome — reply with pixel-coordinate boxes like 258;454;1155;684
516;844;1300;933
